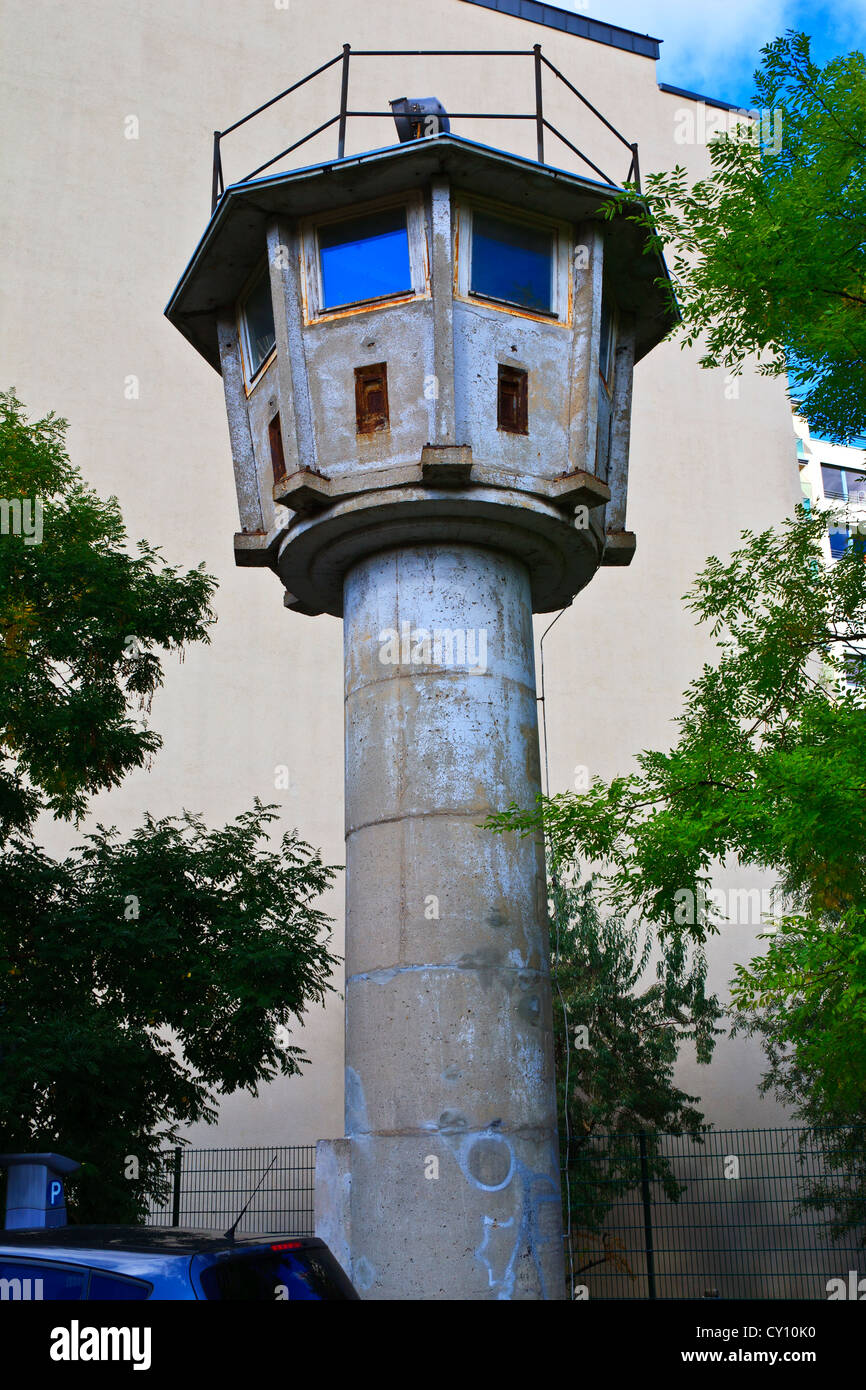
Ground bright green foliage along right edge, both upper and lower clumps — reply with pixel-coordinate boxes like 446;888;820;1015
525;31;866;1251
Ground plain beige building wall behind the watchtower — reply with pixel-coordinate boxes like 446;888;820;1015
0;0;799;1145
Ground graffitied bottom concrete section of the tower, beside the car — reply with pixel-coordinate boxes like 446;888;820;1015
316;1129;566;1301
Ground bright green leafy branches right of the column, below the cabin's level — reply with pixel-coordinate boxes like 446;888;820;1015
491;507;866;1239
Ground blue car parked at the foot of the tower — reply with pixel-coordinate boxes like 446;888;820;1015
0;1226;359;1302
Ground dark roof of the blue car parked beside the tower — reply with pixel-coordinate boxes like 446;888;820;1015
0;1226;322;1255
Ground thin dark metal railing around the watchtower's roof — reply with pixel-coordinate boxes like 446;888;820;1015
211;43;641;214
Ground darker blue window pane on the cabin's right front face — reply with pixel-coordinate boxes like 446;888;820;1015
470;213;553;311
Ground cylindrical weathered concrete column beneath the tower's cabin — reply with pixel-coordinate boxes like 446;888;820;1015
343;543;564;1300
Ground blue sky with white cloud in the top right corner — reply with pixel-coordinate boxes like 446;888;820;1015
555;0;866;107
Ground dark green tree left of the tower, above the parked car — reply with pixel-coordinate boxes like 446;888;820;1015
0;393;336;1220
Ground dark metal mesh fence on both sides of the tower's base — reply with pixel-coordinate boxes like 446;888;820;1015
139;1126;866;1300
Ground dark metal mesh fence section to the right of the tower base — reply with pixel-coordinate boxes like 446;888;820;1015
569;1126;866;1300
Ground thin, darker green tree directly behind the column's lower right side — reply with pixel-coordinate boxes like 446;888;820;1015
550;866;721;1277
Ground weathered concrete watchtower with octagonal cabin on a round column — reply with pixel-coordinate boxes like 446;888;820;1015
167;56;670;1300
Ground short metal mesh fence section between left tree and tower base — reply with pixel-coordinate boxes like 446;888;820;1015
147;1144;316;1236
